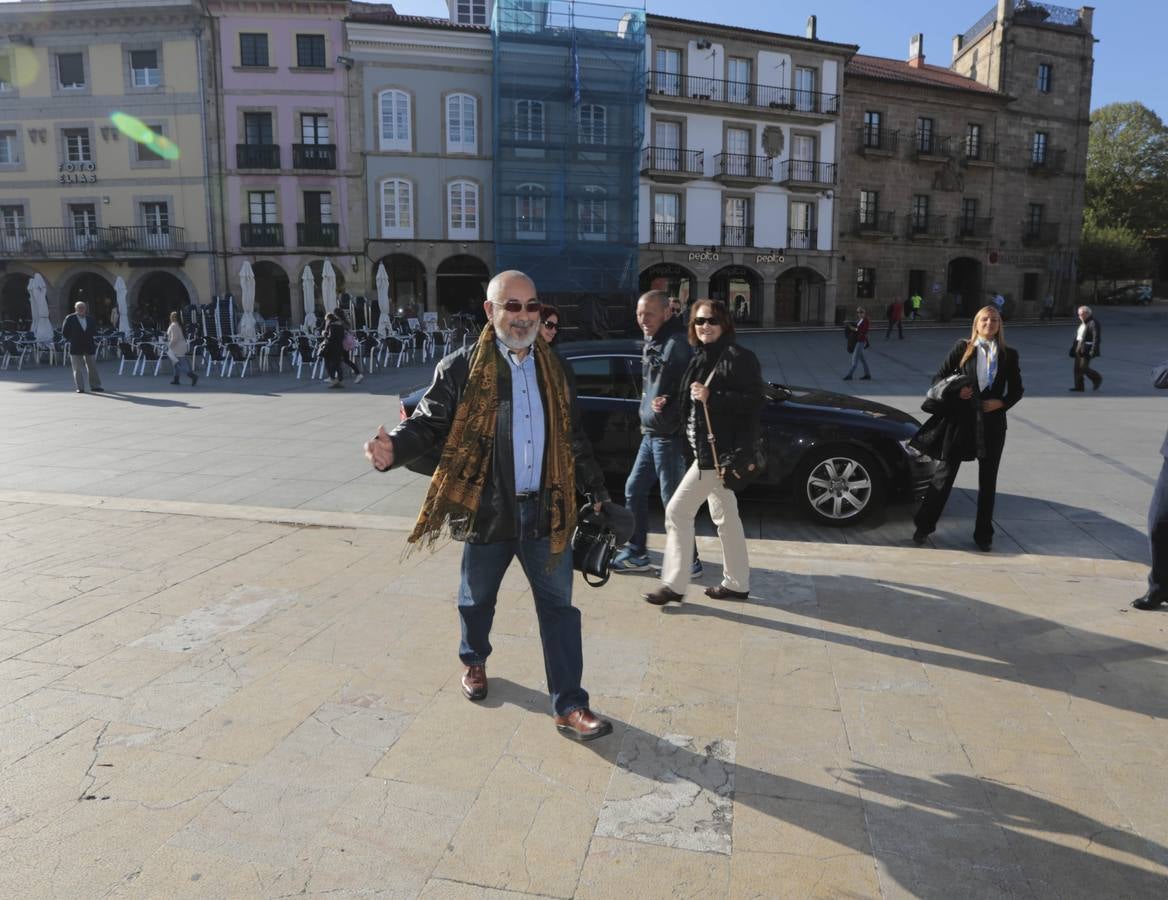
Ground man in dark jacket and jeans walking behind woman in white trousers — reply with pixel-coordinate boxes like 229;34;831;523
612;291;702;575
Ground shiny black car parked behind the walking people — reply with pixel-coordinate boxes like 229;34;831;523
401;341;937;525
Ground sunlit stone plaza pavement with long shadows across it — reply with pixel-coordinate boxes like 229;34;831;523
0;305;1168;898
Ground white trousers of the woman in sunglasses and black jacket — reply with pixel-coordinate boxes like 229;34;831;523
661;462;750;594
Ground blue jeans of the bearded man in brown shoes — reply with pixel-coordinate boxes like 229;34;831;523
458;498;588;716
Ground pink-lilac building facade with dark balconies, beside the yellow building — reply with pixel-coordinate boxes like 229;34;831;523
206;0;359;323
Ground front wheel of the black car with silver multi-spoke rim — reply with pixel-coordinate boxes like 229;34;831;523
795;447;885;526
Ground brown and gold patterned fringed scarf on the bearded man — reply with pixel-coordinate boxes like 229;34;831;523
409;322;576;570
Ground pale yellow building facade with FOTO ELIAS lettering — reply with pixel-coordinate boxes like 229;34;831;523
0;0;216;325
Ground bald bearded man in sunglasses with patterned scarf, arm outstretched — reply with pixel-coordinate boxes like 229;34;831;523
364;270;612;740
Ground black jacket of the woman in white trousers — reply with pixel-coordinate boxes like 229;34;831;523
681;339;766;469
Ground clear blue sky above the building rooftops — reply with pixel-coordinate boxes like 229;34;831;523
387;0;1168;119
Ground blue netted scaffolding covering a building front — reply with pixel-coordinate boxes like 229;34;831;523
492;0;645;304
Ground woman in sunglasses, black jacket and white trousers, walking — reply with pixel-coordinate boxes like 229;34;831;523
645;300;766;606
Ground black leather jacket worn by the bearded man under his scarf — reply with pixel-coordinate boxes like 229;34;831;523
389;346;610;544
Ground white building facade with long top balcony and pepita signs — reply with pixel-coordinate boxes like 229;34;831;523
639;15;856;326
